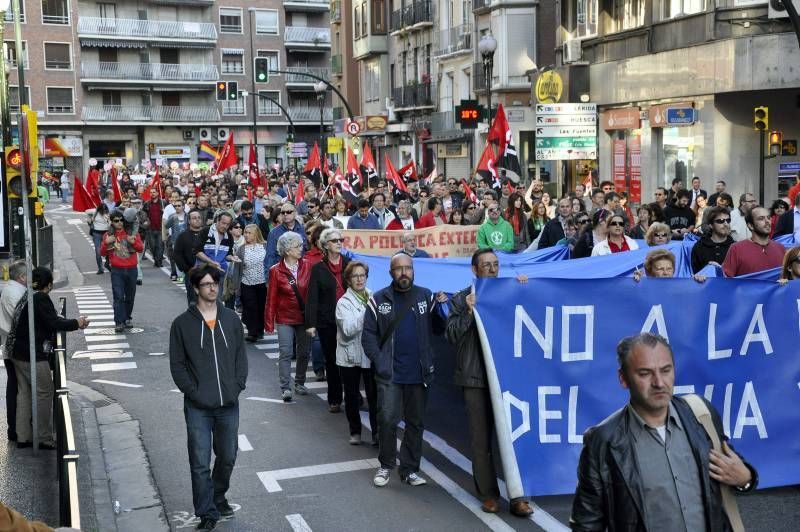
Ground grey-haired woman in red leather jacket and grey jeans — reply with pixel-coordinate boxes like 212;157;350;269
264;231;311;403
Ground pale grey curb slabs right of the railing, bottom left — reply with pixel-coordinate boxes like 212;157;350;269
67;381;170;532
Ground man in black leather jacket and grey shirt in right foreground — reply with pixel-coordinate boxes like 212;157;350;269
570;333;758;532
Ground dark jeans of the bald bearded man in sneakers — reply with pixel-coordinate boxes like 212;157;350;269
376;380;428;477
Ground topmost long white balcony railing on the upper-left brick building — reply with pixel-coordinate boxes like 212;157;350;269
78;17;217;42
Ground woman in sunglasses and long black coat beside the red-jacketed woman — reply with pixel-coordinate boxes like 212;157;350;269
305;229;350;414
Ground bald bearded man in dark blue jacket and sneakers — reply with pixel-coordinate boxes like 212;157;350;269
361;252;447;487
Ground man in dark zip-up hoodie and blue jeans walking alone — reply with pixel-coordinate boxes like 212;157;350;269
169;264;247;530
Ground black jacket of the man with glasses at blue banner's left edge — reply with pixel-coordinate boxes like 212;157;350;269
445;287;487;388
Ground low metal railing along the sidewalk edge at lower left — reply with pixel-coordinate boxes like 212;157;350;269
53;297;81;529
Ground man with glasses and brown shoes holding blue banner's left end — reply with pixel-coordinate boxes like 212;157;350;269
445;248;533;517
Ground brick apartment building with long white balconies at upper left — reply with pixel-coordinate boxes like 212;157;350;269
4;0;332;174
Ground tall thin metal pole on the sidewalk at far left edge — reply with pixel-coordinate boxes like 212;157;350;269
12;0;37;454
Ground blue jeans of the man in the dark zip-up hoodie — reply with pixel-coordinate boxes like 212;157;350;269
183;398;239;521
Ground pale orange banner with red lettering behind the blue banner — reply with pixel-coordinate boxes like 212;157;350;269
342;225;478;257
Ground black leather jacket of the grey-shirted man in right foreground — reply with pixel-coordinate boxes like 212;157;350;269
569;397;758;532
